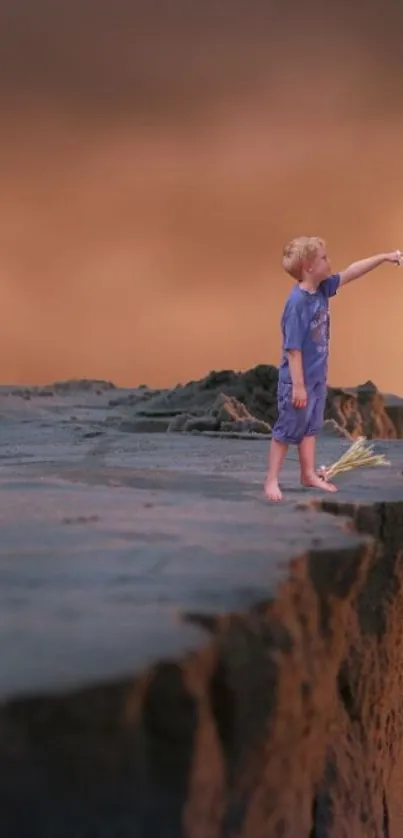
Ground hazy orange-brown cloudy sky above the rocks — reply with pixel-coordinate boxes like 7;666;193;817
0;0;403;393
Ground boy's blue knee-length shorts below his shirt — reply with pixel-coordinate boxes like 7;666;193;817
272;381;327;445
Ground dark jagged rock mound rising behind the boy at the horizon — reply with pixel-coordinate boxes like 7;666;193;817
109;364;403;439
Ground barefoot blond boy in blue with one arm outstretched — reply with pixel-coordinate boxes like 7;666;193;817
264;241;402;501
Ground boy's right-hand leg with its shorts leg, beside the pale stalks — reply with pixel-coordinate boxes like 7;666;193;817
298;384;337;492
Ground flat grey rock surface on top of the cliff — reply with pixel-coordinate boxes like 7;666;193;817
0;394;403;699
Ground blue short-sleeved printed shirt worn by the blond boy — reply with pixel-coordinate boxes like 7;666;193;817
279;274;340;387
